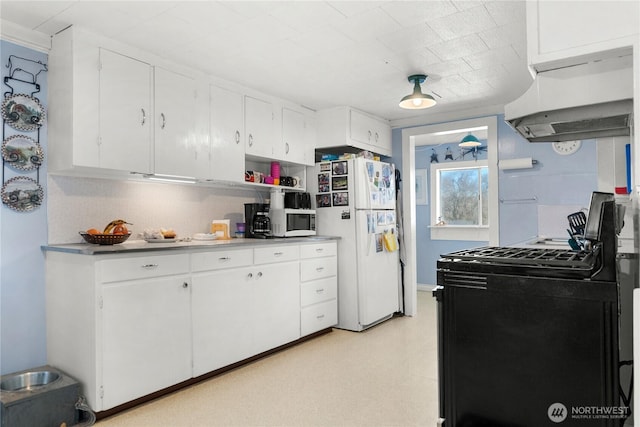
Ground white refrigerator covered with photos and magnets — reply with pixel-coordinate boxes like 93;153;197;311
308;158;400;331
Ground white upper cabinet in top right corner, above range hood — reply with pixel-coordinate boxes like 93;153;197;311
526;0;640;72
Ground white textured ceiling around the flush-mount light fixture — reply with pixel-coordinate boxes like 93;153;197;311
0;0;531;122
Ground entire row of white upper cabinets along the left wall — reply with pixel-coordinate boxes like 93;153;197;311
48;27;315;182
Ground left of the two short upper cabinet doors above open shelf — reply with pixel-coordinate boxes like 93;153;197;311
245;96;273;158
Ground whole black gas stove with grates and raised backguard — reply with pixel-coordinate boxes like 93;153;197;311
434;193;626;427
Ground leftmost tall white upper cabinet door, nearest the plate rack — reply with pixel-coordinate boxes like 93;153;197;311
99;49;152;173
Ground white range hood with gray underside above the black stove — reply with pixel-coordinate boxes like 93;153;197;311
505;55;633;142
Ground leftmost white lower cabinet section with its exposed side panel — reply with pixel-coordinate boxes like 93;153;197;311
46;252;191;411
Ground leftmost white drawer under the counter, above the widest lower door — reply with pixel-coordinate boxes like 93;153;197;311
97;254;189;283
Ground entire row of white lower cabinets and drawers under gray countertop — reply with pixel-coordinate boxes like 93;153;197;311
46;241;337;412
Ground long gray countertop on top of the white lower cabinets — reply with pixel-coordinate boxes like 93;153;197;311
41;236;340;255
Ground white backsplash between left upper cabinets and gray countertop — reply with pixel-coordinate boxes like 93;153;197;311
47;176;262;244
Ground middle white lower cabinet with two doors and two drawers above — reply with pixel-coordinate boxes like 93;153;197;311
191;245;300;376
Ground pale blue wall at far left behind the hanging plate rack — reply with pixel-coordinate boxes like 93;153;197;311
0;41;48;374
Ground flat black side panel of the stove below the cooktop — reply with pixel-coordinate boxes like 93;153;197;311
436;271;620;427
